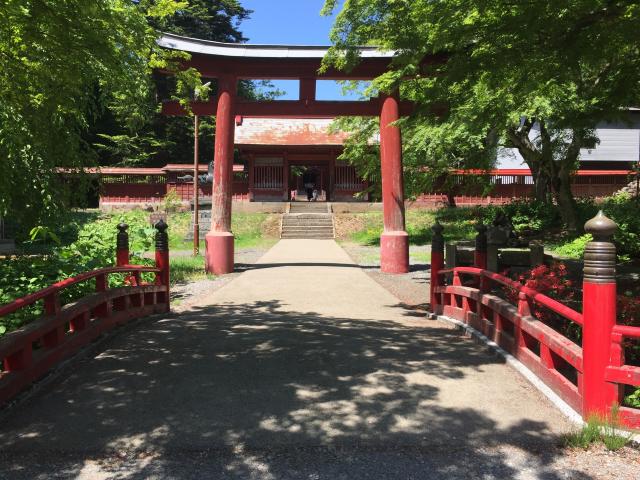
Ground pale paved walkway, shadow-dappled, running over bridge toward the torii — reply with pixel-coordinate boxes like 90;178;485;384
0;240;589;479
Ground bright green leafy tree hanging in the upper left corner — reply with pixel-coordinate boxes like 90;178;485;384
0;0;185;232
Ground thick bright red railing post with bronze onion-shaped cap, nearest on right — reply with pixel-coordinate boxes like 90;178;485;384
582;211;621;418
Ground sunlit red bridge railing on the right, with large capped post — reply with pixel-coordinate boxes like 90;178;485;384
431;212;640;428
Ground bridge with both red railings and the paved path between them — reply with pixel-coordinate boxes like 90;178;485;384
0;216;640;479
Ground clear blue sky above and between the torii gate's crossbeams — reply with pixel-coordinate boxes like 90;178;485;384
240;0;356;100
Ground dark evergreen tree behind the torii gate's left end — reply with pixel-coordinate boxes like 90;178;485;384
93;0;282;166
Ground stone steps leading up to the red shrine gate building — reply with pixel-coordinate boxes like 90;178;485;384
280;202;334;239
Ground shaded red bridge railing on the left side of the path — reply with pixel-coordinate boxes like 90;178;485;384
0;221;170;405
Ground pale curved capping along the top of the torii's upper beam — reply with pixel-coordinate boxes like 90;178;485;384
157;33;395;59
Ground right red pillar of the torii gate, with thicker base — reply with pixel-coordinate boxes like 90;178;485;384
380;95;409;273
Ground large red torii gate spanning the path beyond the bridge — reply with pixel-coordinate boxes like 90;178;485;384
158;34;411;274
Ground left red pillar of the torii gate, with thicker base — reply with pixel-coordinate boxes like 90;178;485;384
205;76;237;275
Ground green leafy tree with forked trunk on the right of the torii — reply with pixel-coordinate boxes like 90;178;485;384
324;0;640;230
